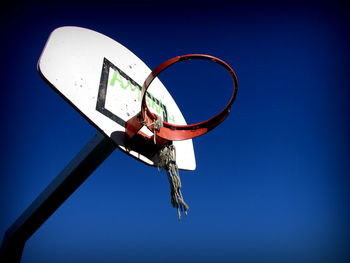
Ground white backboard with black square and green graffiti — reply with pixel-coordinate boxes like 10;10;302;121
38;27;196;170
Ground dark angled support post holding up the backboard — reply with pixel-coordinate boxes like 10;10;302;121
0;133;116;263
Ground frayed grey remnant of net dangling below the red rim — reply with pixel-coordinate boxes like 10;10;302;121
158;144;189;220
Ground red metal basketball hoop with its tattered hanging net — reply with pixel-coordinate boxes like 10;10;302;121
125;54;238;219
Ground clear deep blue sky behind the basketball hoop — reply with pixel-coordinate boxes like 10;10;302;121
0;1;350;263
